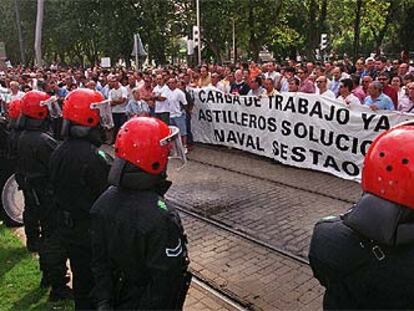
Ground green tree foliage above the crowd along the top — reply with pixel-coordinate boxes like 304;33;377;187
0;0;414;64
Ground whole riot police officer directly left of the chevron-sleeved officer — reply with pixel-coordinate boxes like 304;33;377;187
50;89;113;309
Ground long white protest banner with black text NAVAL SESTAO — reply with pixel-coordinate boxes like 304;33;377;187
191;88;414;181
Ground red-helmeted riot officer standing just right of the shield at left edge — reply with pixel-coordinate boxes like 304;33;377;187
16;91;71;300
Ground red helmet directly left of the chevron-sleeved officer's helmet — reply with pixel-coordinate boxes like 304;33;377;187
63;89;104;127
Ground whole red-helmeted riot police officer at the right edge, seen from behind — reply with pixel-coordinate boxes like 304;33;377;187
309;123;414;309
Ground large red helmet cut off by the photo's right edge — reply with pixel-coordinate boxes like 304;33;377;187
362;122;414;209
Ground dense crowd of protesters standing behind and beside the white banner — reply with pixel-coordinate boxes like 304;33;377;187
0;56;414;147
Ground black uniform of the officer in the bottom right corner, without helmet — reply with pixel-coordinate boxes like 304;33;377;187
309;194;414;310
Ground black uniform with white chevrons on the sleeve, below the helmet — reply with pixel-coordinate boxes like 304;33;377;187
91;159;191;310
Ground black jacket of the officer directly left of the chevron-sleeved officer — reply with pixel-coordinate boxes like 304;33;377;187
50;127;110;221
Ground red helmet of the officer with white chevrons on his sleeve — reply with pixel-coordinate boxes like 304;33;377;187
115;117;173;175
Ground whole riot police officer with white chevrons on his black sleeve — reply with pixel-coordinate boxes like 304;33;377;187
91;117;191;310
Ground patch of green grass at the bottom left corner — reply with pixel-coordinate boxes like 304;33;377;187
0;223;73;310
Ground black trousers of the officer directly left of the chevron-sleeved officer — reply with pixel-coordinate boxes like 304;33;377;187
53;216;94;310
